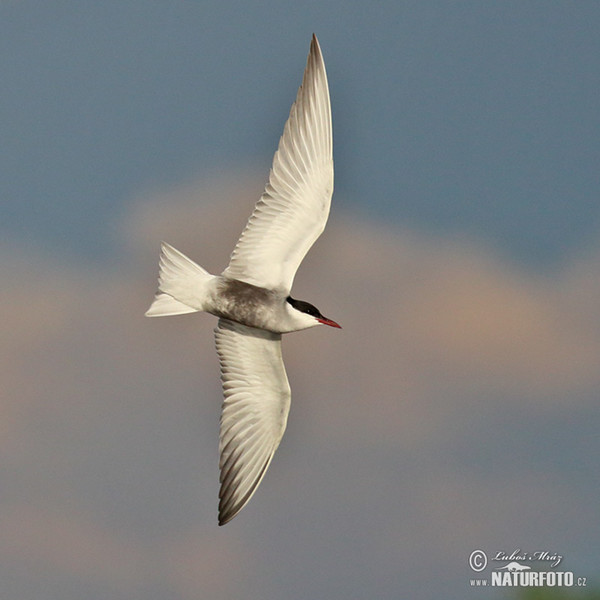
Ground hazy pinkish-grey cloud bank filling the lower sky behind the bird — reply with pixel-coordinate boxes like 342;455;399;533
0;174;600;600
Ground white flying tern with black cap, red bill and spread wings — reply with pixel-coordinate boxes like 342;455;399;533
146;34;341;525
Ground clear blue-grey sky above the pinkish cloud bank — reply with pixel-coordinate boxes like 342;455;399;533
0;1;600;267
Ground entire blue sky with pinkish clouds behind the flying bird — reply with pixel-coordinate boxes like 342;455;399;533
0;0;600;600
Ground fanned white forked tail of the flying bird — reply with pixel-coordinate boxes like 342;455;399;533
146;242;213;317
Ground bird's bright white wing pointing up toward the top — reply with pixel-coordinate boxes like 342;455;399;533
223;35;333;293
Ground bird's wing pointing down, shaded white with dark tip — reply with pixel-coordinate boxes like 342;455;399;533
215;319;291;525
